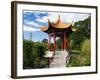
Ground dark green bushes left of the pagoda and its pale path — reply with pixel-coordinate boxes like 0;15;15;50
23;40;48;69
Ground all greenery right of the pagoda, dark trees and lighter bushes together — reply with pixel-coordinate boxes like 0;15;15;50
67;17;91;67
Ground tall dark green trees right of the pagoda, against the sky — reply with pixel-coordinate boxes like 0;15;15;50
71;16;91;49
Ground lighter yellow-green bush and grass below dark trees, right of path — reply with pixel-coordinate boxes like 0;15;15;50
67;39;91;67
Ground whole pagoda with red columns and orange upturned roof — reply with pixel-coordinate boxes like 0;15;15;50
40;15;76;67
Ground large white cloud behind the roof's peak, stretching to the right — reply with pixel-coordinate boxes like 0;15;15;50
48;12;90;23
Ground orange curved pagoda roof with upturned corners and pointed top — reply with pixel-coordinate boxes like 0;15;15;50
40;16;76;32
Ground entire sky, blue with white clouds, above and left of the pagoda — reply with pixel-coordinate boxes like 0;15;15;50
23;10;90;42
